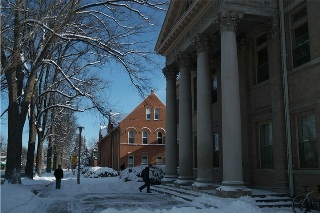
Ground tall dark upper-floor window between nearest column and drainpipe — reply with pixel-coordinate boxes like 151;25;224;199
256;33;269;83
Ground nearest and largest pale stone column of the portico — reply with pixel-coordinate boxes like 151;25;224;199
216;12;243;186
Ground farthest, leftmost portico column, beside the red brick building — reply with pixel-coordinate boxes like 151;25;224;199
162;67;178;184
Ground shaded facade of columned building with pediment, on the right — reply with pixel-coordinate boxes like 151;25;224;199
155;0;320;196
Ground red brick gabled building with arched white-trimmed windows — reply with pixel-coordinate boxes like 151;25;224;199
98;90;166;170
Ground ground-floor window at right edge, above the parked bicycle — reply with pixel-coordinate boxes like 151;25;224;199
297;114;318;168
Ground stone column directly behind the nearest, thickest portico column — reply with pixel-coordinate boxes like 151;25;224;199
193;35;213;187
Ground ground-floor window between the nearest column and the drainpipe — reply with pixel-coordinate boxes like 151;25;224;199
259;123;273;169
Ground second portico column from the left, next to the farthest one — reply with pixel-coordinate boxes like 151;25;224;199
175;53;193;185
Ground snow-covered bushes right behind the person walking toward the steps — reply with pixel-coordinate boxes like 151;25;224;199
119;165;165;185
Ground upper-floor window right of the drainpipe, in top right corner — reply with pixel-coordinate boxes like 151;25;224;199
291;7;310;67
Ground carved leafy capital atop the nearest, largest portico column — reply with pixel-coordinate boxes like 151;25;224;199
214;10;243;31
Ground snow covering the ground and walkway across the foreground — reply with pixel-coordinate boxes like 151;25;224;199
1;166;292;213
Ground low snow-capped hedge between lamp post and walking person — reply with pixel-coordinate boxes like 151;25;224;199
81;166;118;178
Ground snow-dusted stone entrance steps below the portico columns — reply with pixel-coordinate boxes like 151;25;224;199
152;184;292;208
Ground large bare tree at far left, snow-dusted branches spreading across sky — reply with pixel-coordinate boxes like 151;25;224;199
1;0;166;183
